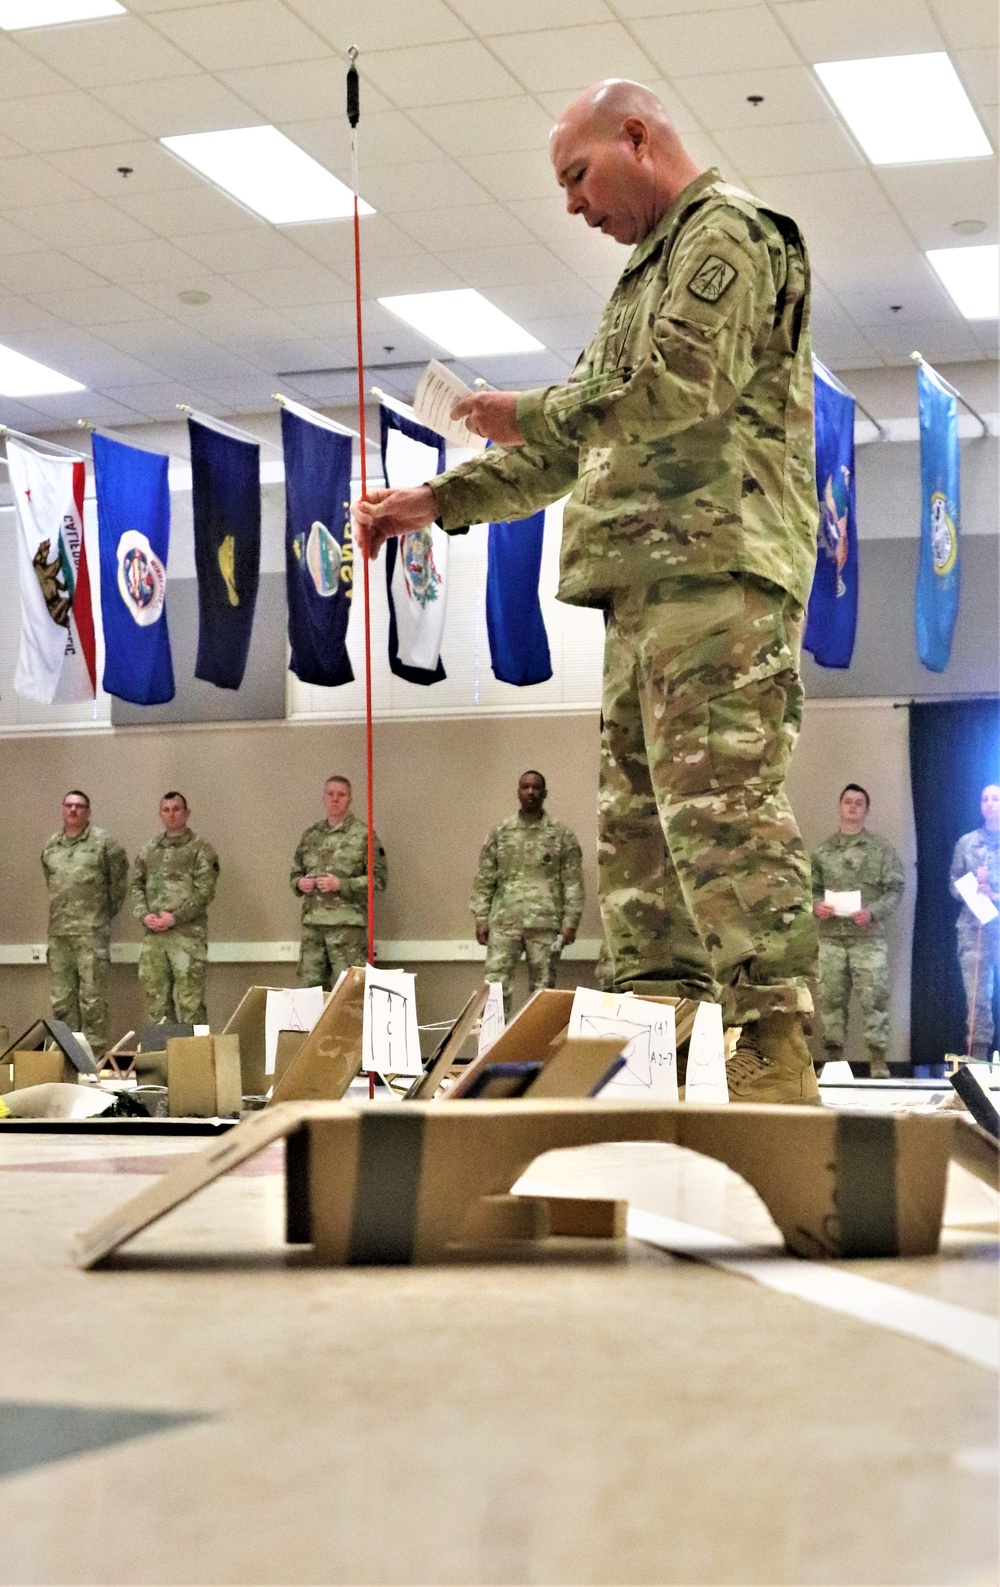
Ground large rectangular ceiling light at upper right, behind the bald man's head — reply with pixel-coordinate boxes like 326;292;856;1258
814;52;994;165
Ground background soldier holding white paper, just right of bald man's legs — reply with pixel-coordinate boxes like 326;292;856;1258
811;782;903;1079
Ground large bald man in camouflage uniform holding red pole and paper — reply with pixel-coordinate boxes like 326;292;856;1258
354;81;819;1101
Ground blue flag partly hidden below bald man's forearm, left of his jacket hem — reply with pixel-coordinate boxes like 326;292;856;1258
486;511;552;689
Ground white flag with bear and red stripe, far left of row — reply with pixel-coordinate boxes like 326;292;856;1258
6;438;97;705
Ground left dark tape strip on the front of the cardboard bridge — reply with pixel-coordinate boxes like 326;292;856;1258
348;1109;424;1265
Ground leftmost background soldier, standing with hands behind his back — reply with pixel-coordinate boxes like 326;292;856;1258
41;789;129;1057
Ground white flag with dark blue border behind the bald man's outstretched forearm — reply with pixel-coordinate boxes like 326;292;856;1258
379;406;448;684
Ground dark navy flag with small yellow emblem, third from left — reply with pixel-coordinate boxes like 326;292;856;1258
187;419;260;689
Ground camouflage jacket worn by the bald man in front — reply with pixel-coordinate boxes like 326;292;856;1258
430;170;819;606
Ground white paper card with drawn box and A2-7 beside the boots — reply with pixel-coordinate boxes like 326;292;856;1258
568;987;678;1101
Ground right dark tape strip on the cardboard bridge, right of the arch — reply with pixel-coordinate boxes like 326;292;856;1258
837;1112;898;1257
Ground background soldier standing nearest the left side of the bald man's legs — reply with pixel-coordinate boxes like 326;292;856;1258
470;771;584;1017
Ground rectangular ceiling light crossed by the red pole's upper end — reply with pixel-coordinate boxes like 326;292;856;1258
160;127;375;225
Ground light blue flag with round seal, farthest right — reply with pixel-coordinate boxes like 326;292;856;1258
916;363;960;673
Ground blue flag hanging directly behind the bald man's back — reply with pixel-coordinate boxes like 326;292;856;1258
802;359;859;667
